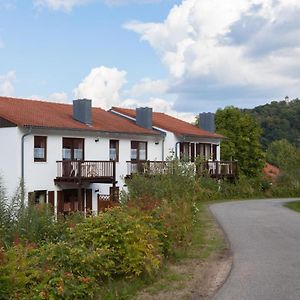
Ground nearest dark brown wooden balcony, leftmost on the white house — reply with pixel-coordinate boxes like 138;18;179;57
54;160;116;184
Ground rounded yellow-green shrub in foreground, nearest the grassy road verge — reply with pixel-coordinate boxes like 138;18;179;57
70;207;161;277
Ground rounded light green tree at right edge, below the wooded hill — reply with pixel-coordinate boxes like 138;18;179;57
267;139;300;170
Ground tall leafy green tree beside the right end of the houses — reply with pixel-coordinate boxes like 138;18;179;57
215;106;265;177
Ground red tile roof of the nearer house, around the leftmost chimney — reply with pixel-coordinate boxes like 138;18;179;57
0;97;158;135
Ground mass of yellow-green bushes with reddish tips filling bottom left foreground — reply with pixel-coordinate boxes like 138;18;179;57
0;207;162;299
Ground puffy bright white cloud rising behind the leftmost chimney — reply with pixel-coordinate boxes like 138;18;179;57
74;66;127;109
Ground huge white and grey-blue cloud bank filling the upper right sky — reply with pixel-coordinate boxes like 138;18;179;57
124;0;300;110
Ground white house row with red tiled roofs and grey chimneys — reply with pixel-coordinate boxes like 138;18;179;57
0;97;231;213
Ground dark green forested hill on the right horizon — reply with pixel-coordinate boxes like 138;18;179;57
243;99;300;149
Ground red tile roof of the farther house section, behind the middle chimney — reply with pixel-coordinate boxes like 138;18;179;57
111;107;224;138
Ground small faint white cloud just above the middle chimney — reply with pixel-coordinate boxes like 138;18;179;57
130;78;168;97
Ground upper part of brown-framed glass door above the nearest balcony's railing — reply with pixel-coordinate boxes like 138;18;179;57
62;138;84;160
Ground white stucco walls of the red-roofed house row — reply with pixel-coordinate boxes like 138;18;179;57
0;122;220;210
